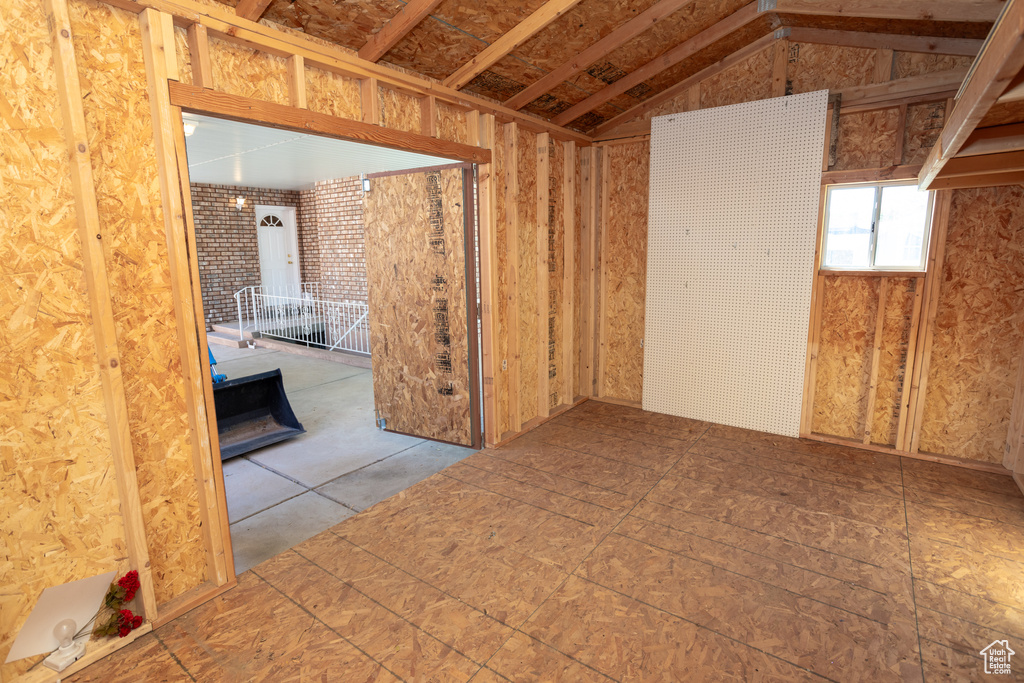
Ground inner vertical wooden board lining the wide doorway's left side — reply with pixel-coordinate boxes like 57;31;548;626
172;108;234;586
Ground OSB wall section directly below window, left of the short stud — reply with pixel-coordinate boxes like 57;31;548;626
811;278;879;439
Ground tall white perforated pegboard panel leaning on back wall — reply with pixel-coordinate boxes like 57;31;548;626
643;90;828;436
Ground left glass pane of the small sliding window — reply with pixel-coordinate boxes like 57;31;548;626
824;187;874;268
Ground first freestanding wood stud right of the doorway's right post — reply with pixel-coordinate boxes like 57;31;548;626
504;122;522;433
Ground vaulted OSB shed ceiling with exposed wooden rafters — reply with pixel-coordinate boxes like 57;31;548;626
222;0;1004;132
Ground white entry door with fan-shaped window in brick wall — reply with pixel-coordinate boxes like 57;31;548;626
256;204;300;296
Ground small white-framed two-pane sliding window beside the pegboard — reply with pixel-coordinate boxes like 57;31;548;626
821;182;933;271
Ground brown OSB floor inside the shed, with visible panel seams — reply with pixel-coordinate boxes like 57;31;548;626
66;401;1024;683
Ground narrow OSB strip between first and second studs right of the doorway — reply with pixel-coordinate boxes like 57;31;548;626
512;130;548;422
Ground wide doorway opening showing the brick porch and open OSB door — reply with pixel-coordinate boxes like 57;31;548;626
183;113;480;572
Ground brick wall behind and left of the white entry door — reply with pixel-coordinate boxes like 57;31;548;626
191;183;309;327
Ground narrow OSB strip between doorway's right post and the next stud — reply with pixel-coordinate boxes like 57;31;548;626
490;125;512;435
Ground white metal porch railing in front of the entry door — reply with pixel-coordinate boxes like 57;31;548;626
234;283;370;355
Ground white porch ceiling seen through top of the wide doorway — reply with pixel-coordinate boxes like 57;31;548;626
183;114;453;189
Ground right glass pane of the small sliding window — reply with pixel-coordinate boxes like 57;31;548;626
874;185;928;268
